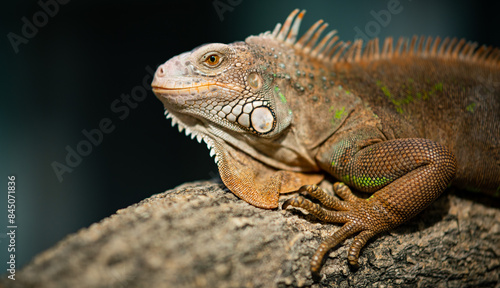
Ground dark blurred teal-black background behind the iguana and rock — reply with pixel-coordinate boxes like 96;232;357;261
0;0;500;274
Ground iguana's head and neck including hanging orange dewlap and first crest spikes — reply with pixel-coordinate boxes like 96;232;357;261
152;10;338;208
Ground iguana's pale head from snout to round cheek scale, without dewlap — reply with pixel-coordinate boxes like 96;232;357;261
152;42;290;137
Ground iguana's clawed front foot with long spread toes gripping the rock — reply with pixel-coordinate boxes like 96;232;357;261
282;182;384;276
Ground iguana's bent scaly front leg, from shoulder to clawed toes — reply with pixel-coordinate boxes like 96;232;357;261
283;136;456;274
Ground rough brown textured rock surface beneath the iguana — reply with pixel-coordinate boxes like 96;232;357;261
0;182;500;287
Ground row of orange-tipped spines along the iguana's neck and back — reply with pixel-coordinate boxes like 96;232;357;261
260;9;500;66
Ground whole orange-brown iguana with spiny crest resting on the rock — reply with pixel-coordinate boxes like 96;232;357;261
152;9;500;274
